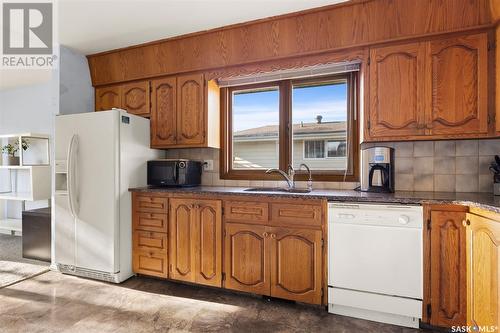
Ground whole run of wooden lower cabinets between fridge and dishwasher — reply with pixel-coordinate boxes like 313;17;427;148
132;193;324;304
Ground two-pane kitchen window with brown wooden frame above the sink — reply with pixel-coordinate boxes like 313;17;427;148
221;72;359;181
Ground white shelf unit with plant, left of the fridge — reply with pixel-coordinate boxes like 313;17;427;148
0;133;52;235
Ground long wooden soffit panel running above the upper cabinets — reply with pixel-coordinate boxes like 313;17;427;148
87;0;496;86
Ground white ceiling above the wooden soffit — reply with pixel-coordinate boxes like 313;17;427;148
58;0;346;55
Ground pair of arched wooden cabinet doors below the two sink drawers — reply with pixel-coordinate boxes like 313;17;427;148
224;223;322;304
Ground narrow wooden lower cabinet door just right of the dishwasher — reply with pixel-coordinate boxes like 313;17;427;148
429;210;467;328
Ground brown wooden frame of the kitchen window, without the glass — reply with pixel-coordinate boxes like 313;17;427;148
220;72;360;182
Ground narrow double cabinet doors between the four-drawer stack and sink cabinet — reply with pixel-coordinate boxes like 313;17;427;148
169;199;222;287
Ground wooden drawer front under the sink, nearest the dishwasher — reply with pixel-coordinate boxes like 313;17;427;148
271;203;322;226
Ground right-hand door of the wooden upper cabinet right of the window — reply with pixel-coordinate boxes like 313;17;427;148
427;33;488;135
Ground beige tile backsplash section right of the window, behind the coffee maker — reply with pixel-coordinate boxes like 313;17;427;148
362;139;500;192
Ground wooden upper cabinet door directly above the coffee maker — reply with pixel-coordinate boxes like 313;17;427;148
366;43;425;139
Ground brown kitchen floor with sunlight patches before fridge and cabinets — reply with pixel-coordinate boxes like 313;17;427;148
0;272;440;333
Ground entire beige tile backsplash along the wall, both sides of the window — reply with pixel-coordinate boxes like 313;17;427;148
166;139;500;192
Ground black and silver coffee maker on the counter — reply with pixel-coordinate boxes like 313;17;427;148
361;147;394;192
